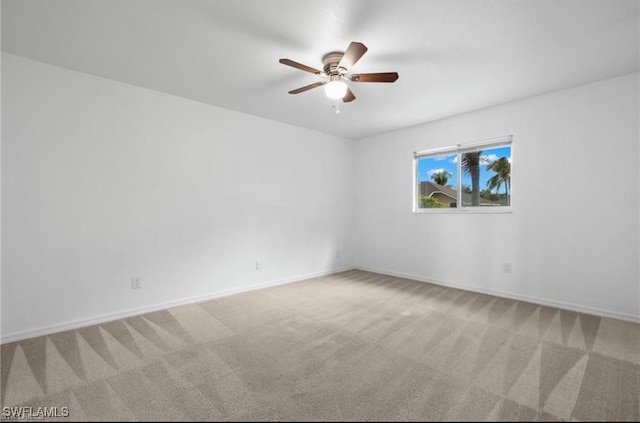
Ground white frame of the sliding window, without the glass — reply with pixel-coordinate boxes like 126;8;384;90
412;135;513;214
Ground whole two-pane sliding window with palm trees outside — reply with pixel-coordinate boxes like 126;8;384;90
414;136;512;211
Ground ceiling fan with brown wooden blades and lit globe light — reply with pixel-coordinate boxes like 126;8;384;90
280;41;398;103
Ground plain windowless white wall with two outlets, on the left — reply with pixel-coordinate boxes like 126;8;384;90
2;54;352;341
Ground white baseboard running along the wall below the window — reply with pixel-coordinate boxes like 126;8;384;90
354;266;640;323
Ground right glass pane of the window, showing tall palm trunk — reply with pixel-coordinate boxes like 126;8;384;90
461;146;511;207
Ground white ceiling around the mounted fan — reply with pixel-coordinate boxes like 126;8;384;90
2;0;639;138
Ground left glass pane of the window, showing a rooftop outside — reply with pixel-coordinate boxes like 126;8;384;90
417;153;458;209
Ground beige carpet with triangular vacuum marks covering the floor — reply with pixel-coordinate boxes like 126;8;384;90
1;271;640;421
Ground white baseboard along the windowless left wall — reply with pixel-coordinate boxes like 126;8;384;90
0;266;353;344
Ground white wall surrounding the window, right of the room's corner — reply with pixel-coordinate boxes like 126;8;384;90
354;74;640;319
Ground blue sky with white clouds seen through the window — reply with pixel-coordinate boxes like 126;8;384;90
418;146;511;193
